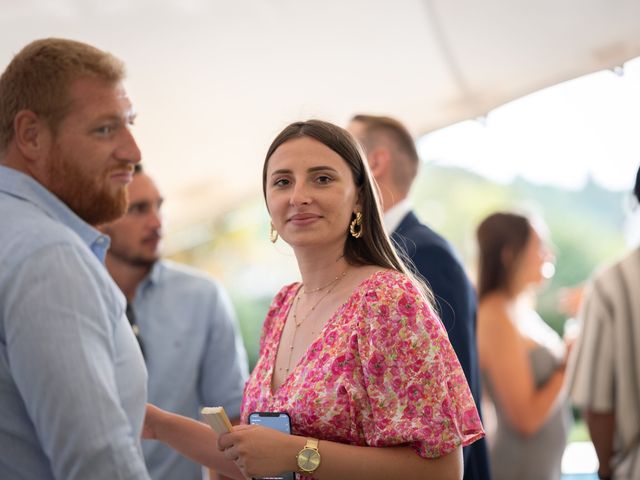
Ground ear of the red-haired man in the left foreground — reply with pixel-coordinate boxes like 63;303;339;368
13;110;52;163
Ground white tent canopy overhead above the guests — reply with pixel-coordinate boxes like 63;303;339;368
0;0;640;229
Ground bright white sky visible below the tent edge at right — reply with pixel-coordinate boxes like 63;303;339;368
418;58;640;190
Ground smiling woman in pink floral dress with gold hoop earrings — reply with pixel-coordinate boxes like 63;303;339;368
144;120;483;480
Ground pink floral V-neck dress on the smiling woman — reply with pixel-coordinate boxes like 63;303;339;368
242;270;484;472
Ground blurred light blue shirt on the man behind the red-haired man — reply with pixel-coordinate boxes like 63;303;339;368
133;260;247;480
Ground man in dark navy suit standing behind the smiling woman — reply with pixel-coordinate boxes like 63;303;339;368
348;115;490;480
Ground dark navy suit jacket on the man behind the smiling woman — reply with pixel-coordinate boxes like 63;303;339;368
391;212;491;480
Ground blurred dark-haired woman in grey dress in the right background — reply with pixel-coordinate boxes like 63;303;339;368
477;212;573;480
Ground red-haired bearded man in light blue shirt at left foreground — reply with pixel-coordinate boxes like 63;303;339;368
0;39;149;480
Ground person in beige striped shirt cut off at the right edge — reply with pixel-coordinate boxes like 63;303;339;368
568;169;640;480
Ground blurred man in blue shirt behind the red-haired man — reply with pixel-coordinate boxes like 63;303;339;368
101;164;248;480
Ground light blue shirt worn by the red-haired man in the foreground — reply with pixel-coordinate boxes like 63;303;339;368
0;166;149;480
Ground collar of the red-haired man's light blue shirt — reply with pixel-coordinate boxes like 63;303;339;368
0;165;111;263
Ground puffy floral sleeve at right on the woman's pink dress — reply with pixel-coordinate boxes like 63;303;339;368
358;274;484;458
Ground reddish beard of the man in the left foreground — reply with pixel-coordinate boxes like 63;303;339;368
47;145;129;226
